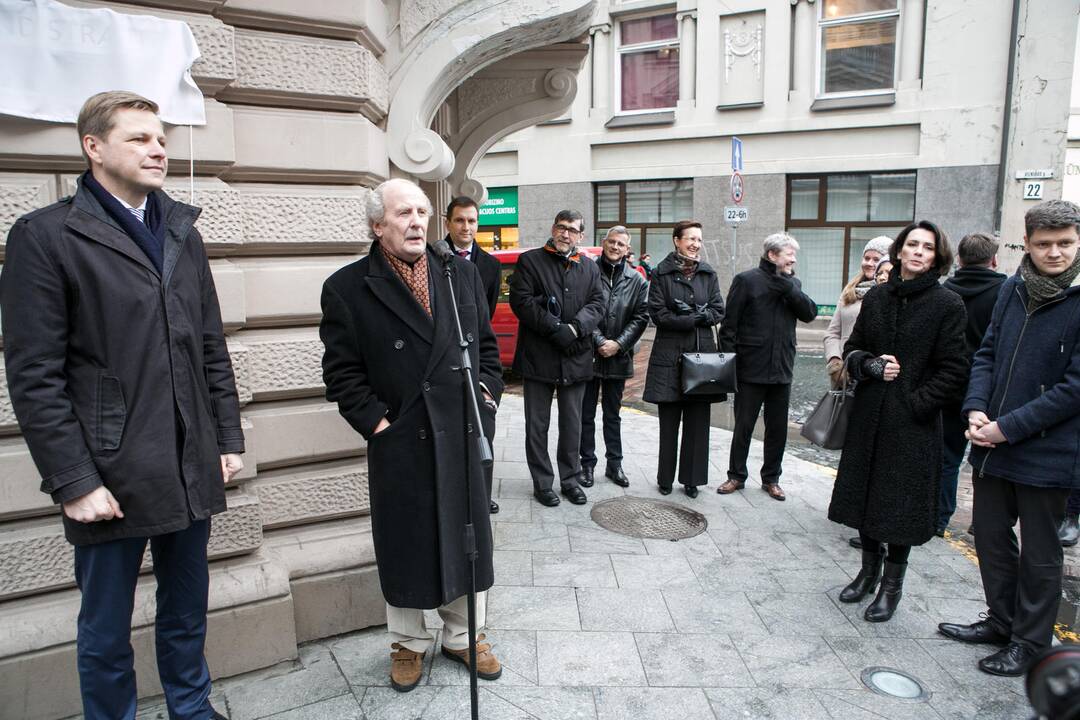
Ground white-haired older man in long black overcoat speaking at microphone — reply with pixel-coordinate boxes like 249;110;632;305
319;179;502;692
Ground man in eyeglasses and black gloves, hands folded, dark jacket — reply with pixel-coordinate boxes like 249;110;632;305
510;210;604;507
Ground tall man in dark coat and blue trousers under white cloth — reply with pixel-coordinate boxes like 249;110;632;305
0;92;244;720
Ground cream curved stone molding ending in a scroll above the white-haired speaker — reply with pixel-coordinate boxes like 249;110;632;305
387;0;596;181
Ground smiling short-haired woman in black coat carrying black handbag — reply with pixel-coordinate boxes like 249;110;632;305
643;220;727;498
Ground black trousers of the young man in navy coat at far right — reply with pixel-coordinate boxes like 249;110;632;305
972;472;1069;649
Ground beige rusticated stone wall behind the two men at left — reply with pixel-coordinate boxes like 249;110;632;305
0;0;594;718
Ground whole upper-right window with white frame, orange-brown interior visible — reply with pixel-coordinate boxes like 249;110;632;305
818;0;900;95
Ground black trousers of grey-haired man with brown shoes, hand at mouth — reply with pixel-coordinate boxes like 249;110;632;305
728;382;792;485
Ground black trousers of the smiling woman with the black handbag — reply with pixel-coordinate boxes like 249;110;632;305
657;402;711;488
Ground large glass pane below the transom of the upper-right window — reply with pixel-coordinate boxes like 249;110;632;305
822;18;896;93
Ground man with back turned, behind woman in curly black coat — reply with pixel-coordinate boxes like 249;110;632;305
936;232;1005;536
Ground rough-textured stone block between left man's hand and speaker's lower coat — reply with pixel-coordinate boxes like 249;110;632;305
248;465;369;529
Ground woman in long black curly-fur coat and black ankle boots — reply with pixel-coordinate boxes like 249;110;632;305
828;220;968;623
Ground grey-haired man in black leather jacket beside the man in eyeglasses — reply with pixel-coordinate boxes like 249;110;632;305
581;226;649;488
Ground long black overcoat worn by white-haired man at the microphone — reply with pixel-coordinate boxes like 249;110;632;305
319;243;502;608
